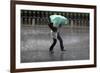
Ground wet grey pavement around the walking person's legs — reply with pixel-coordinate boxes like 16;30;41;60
20;26;89;63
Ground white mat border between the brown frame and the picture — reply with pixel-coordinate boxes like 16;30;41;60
16;4;94;69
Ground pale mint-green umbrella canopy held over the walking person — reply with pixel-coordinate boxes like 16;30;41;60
50;15;68;27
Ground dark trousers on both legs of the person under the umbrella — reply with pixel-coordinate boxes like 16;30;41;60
49;33;64;51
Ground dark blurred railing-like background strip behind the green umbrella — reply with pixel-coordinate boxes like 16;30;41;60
21;10;89;27
